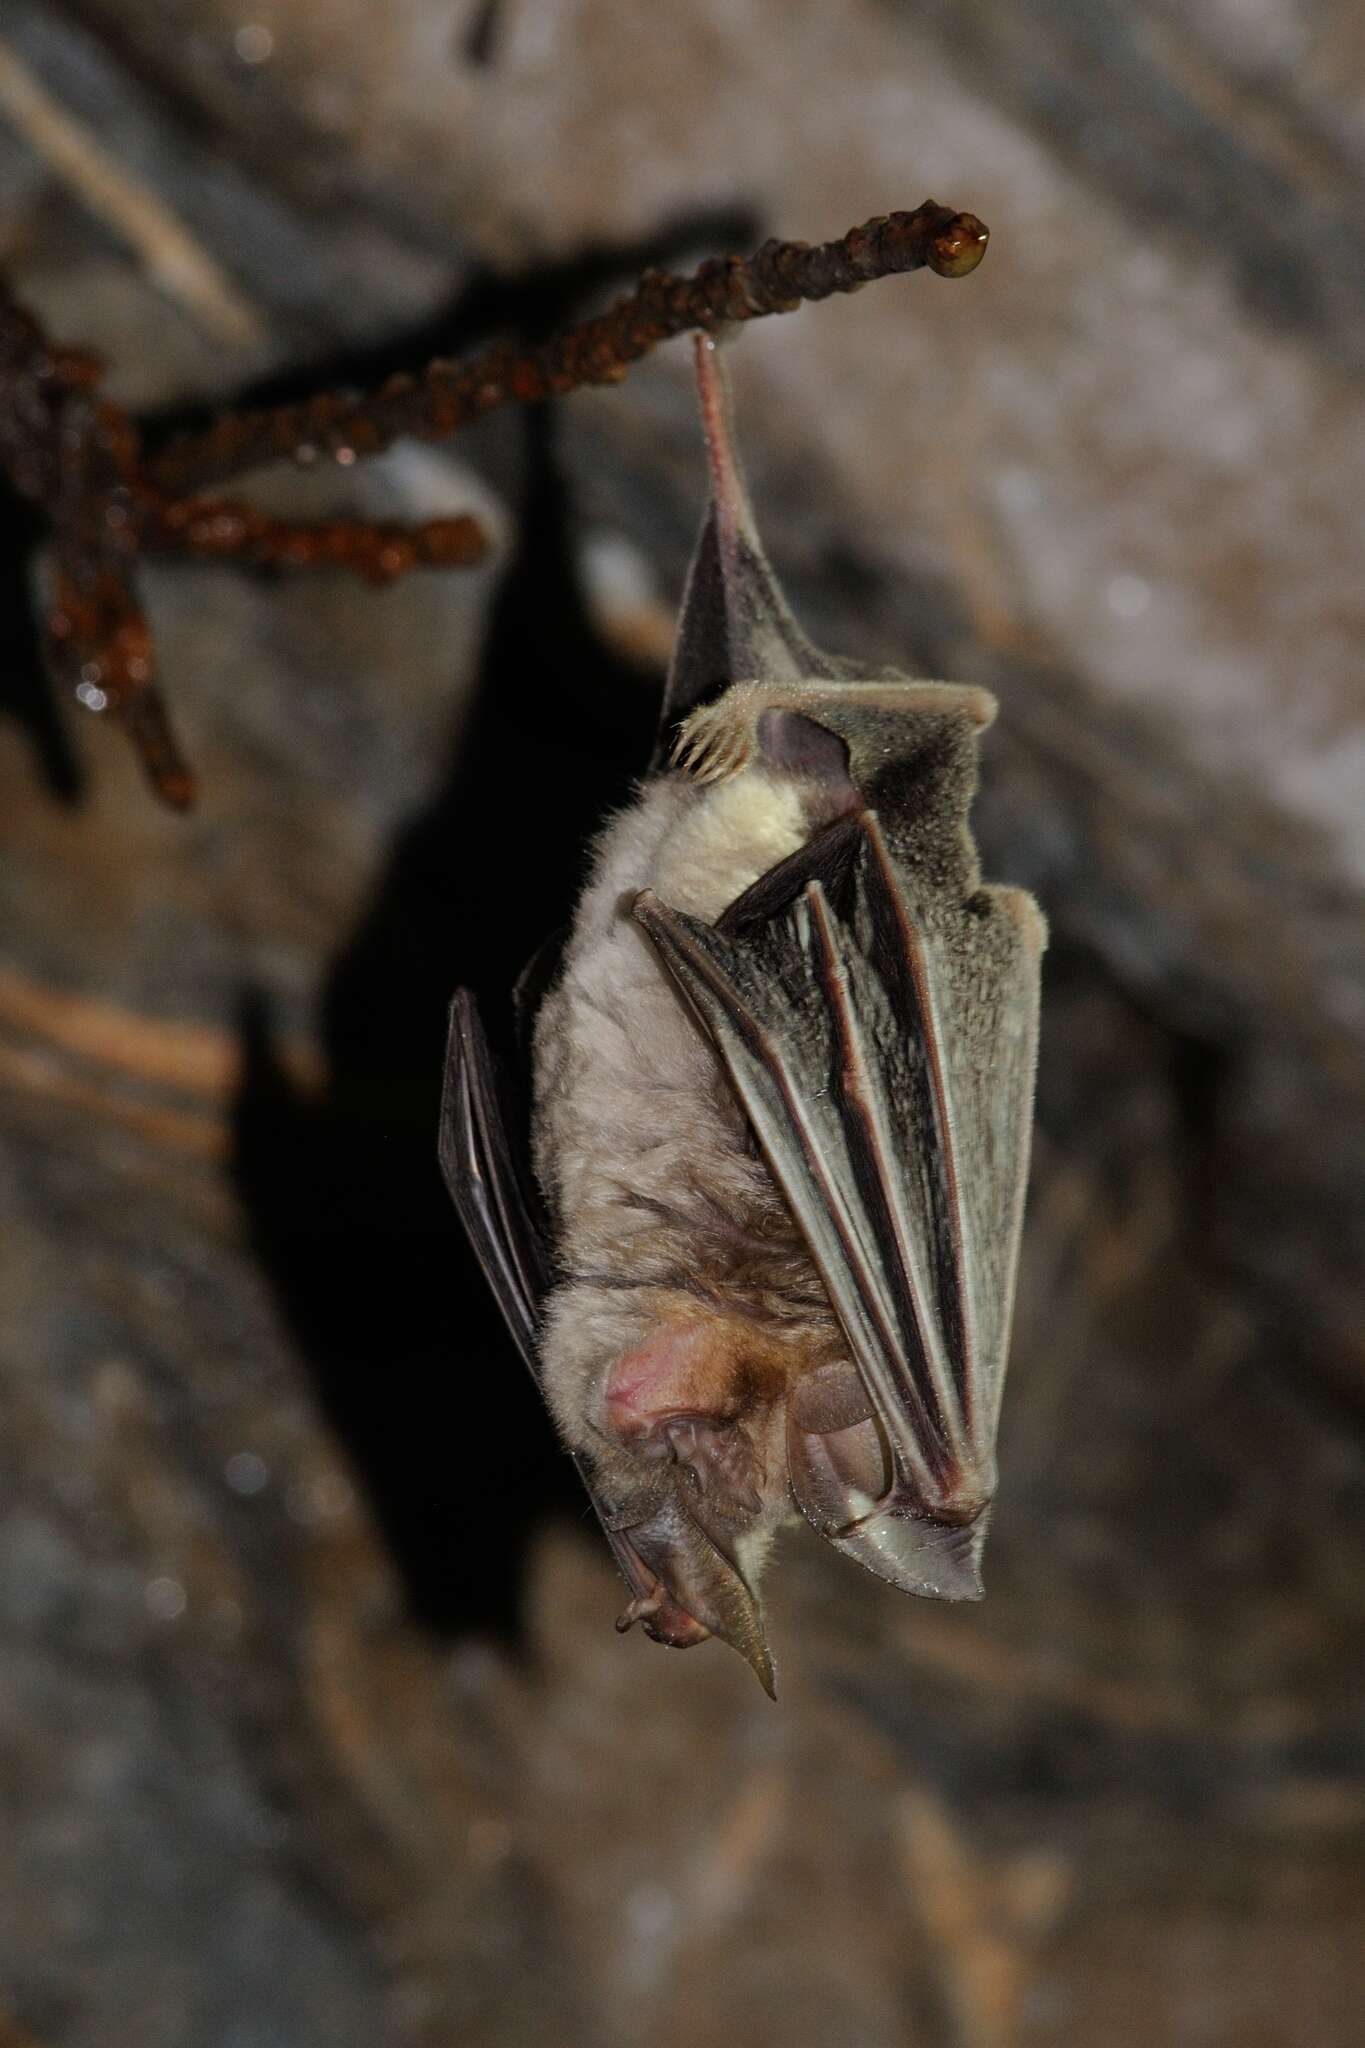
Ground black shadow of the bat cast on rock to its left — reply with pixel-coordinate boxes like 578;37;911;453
235;410;657;1634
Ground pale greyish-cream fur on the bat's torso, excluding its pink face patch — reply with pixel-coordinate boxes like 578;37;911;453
534;766;829;1491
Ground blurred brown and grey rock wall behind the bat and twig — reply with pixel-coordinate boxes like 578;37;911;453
0;0;1365;2048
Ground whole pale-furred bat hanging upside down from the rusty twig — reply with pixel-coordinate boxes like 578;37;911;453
440;338;1046;1692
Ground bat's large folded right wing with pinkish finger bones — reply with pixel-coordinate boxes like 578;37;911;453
636;811;1042;1599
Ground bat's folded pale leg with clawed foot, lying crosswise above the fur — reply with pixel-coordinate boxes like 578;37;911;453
673;676;995;784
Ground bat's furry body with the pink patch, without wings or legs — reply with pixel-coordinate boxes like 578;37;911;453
534;766;837;1646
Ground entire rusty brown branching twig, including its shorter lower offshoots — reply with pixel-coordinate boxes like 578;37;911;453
0;201;986;809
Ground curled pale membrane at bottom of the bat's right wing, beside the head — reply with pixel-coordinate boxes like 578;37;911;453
786;1409;988;1599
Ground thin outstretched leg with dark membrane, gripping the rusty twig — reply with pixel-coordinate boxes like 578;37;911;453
659;334;847;754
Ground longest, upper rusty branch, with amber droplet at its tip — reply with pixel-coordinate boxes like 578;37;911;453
149;199;986;494
